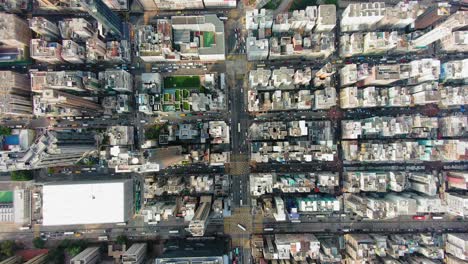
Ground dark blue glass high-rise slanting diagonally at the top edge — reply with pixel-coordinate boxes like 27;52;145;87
81;0;122;35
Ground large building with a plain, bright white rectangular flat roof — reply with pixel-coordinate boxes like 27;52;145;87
42;180;133;226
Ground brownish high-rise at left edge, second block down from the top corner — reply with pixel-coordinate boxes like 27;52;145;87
0;71;32;116
